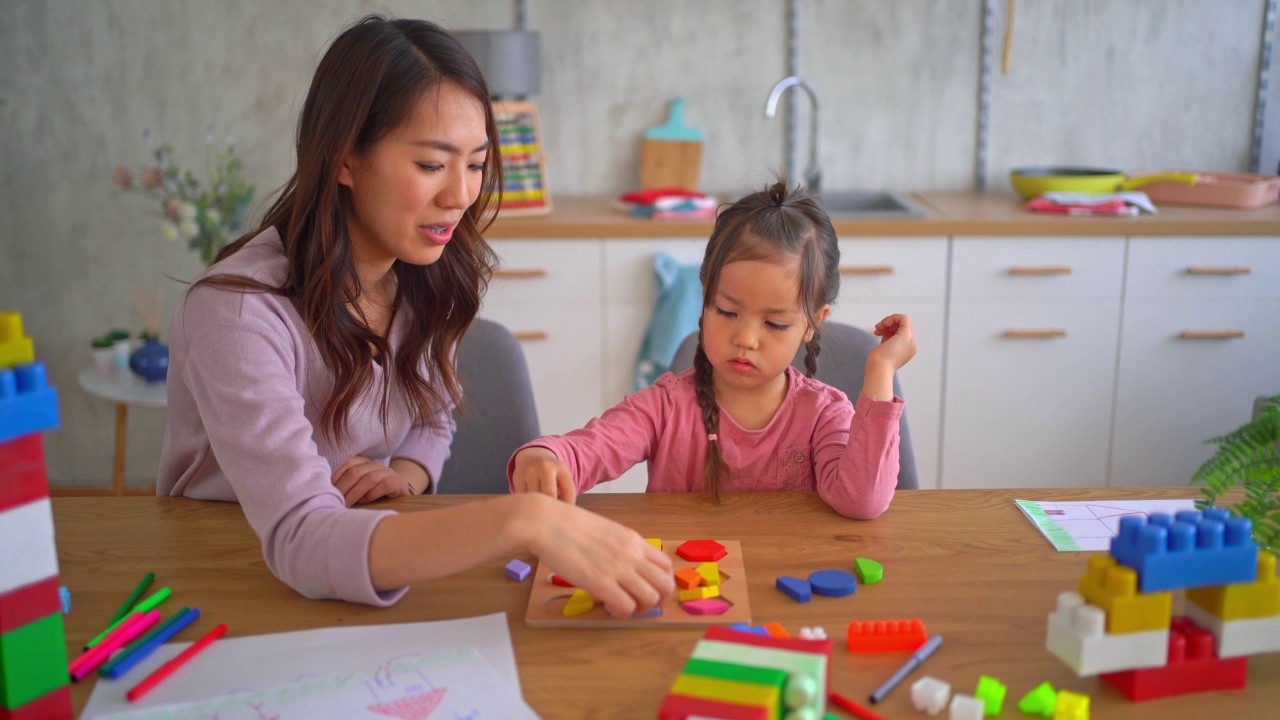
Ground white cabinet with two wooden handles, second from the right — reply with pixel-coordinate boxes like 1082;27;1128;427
941;237;1125;488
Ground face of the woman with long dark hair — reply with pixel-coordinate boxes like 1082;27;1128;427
338;81;490;273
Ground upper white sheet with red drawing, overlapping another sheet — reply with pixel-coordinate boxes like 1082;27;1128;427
93;647;538;720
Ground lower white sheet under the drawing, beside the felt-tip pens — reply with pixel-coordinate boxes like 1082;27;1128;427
81;612;521;720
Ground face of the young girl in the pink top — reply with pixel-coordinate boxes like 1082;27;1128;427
703;258;831;397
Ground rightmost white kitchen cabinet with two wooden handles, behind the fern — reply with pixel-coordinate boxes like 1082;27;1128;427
1110;237;1280;486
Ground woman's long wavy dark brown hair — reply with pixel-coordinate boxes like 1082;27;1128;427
192;15;502;439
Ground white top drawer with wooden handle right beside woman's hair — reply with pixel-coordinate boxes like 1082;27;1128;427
484;240;602;305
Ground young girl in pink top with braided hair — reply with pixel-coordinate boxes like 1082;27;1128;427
508;182;915;519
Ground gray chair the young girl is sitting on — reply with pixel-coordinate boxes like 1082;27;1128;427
671;320;920;489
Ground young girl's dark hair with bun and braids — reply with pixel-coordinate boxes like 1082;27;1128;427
694;179;840;501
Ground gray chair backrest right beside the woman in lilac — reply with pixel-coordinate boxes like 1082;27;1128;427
436;318;541;495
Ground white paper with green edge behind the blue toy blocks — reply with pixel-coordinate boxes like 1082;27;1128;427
1014;500;1196;551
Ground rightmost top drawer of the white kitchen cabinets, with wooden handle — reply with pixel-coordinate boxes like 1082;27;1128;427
1125;237;1280;300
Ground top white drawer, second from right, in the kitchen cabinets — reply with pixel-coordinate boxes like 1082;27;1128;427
951;237;1124;300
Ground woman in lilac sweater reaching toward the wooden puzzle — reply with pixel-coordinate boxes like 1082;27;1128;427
157;17;673;616
